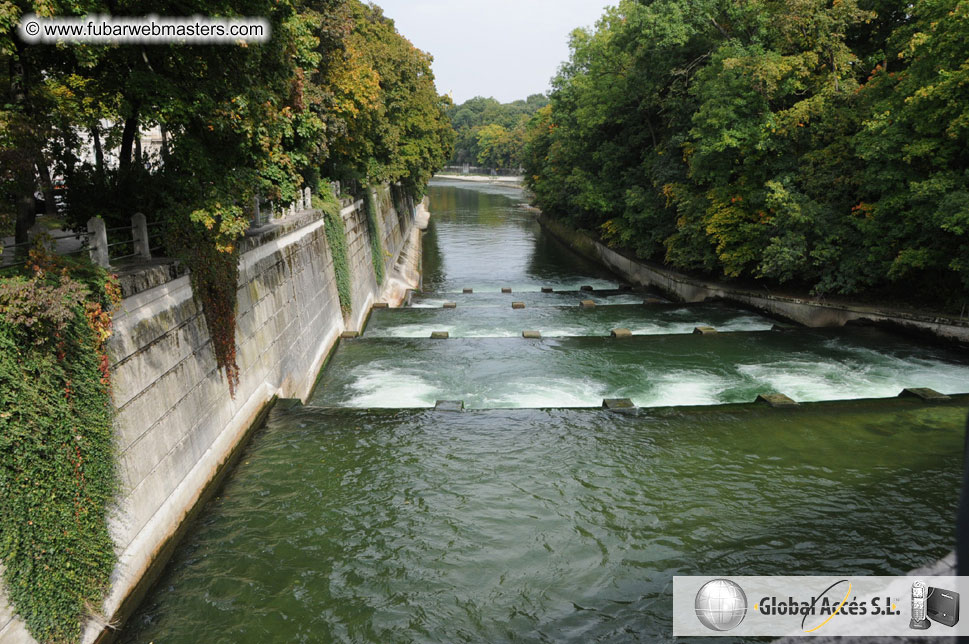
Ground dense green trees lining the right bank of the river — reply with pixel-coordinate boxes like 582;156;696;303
526;0;969;303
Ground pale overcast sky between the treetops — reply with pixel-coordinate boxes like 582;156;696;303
375;0;618;103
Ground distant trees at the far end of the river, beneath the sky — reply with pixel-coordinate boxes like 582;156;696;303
447;94;548;169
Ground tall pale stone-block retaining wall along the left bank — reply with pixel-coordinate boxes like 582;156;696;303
0;186;429;644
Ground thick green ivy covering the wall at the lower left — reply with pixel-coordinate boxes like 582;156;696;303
0;254;117;642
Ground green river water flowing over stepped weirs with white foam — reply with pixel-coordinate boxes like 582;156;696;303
121;182;969;644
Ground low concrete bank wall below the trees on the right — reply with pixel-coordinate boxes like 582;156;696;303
539;214;969;345
